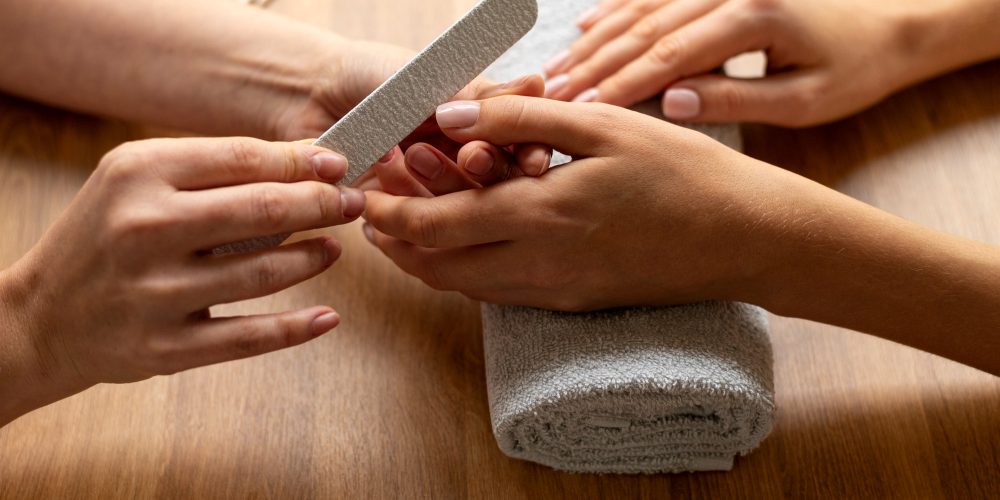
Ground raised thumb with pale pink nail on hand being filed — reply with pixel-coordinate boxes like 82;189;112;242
436;96;628;156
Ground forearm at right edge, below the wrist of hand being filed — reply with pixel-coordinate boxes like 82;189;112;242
756;176;1000;374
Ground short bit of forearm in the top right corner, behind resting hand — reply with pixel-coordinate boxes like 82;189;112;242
896;0;1000;84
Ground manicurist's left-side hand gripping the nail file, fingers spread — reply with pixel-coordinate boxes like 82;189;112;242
0;139;365;424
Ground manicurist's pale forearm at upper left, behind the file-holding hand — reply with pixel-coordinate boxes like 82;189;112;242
0;0;344;137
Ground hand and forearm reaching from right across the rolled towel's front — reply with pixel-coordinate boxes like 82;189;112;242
366;98;1000;374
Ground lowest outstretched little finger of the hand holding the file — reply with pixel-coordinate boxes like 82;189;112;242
170;306;340;371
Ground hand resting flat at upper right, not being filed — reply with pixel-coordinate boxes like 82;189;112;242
546;0;937;126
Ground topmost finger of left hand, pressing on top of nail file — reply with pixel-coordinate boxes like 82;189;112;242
146;137;347;191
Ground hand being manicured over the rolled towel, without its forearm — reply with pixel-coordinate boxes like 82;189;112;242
366;97;825;311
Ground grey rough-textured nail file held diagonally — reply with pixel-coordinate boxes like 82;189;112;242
213;0;538;254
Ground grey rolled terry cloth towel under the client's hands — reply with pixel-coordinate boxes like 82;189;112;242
483;0;774;473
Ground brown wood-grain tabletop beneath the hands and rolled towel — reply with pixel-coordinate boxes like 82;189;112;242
0;0;1000;499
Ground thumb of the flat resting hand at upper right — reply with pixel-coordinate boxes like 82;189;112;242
663;73;812;126
